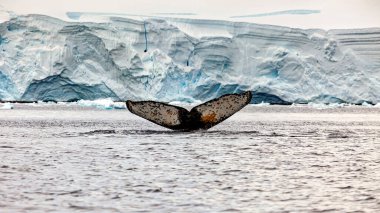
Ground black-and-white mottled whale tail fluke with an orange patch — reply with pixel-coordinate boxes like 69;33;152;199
127;91;252;131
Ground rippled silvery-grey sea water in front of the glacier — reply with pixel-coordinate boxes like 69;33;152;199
0;104;380;212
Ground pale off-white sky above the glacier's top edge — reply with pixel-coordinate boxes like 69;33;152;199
0;0;380;29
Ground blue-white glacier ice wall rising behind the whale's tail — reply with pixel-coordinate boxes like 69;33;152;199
0;15;380;104
